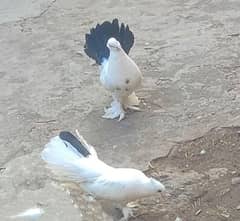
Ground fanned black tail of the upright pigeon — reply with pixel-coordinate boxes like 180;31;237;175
84;18;134;65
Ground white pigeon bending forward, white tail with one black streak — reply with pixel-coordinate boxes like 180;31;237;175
41;131;165;220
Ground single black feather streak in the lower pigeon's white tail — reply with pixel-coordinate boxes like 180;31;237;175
59;131;90;157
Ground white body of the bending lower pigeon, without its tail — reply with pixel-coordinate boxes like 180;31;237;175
83;168;159;202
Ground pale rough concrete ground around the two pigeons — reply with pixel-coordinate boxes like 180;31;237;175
0;0;240;221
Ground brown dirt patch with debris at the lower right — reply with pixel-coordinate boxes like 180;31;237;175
133;127;240;221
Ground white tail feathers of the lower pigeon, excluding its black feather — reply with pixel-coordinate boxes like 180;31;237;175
41;136;110;182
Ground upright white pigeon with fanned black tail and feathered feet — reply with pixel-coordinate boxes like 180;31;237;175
84;19;142;121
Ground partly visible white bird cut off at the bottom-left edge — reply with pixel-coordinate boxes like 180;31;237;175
10;207;45;221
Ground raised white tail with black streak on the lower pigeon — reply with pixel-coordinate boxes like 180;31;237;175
41;131;105;182
